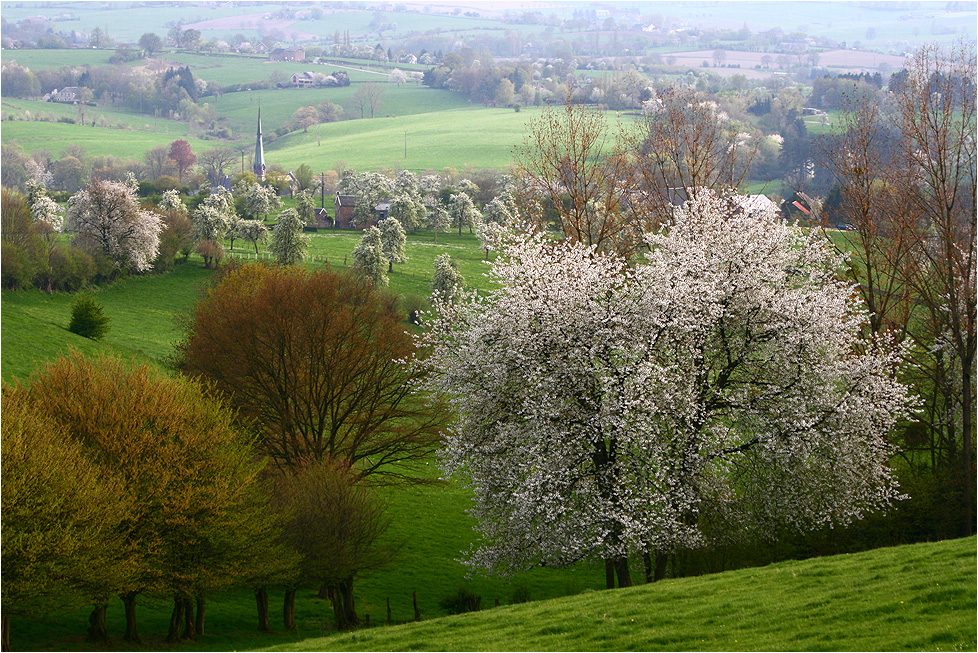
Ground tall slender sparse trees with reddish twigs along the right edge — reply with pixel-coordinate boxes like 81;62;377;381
817;46;978;536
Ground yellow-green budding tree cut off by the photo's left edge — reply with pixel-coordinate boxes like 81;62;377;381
0;389;133;651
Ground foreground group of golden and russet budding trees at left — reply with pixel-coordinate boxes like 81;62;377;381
2;266;447;647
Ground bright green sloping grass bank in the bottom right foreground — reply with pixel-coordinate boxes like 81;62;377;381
269;537;976;651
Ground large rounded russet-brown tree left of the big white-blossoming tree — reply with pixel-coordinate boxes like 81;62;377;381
177;265;446;625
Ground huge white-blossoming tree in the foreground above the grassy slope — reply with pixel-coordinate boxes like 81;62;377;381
418;192;913;586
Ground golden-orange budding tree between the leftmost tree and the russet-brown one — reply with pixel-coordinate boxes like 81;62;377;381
18;353;267;642
